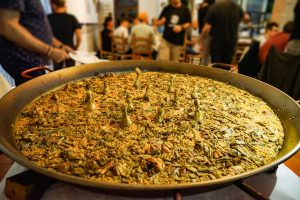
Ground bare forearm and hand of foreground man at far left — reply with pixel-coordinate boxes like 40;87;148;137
0;9;68;62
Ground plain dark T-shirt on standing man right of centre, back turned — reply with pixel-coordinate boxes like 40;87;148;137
204;0;244;51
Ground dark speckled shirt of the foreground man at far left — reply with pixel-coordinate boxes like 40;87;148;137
0;0;52;83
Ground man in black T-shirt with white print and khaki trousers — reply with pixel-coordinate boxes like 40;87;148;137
156;0;191;61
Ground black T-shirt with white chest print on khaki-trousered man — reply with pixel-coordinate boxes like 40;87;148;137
159;4;191;45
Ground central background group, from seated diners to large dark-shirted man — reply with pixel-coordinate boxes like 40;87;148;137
102;0;250;65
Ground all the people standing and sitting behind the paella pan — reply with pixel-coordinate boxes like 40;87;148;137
0;0;300;85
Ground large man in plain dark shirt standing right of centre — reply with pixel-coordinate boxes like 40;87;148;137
202;0;250;63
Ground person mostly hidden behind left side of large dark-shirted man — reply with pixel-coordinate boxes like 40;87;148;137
198;0;215;66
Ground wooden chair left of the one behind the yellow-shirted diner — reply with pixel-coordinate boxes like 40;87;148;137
111;35;132;60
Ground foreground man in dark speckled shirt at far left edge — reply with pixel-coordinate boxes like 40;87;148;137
0;0;71;85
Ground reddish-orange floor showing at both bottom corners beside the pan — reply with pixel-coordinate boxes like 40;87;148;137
0;151;300;181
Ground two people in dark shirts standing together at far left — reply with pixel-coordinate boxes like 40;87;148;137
0;0;81;86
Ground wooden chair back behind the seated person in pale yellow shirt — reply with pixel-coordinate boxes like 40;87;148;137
131;34;153;60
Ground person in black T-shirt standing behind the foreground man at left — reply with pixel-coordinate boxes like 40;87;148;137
48;0;81;70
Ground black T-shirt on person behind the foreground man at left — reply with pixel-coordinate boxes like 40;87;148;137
48;13;81;48
